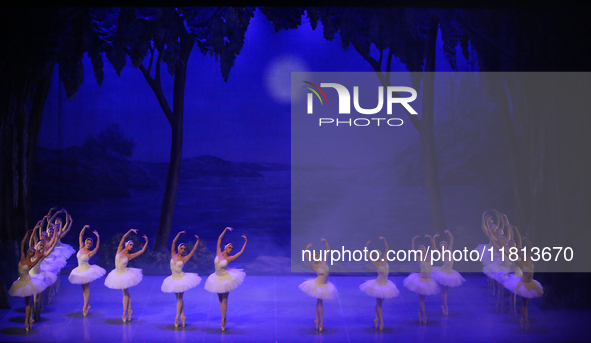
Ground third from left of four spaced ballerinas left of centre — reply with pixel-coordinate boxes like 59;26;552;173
161;231;201;328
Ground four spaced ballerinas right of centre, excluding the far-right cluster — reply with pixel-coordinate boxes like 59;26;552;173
299;230;466;331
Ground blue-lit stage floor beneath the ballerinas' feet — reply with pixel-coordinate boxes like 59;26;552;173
0;274;591;342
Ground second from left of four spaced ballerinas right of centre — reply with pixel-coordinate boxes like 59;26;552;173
359;237;400;330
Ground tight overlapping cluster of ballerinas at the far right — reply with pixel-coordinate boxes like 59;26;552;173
476;209;544;329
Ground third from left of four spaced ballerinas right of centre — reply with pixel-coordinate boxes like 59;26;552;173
402;235;439;323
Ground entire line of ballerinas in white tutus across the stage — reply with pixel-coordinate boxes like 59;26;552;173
9;208;543;331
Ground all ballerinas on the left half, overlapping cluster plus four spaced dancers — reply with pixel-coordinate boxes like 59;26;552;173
9;208;247;331
